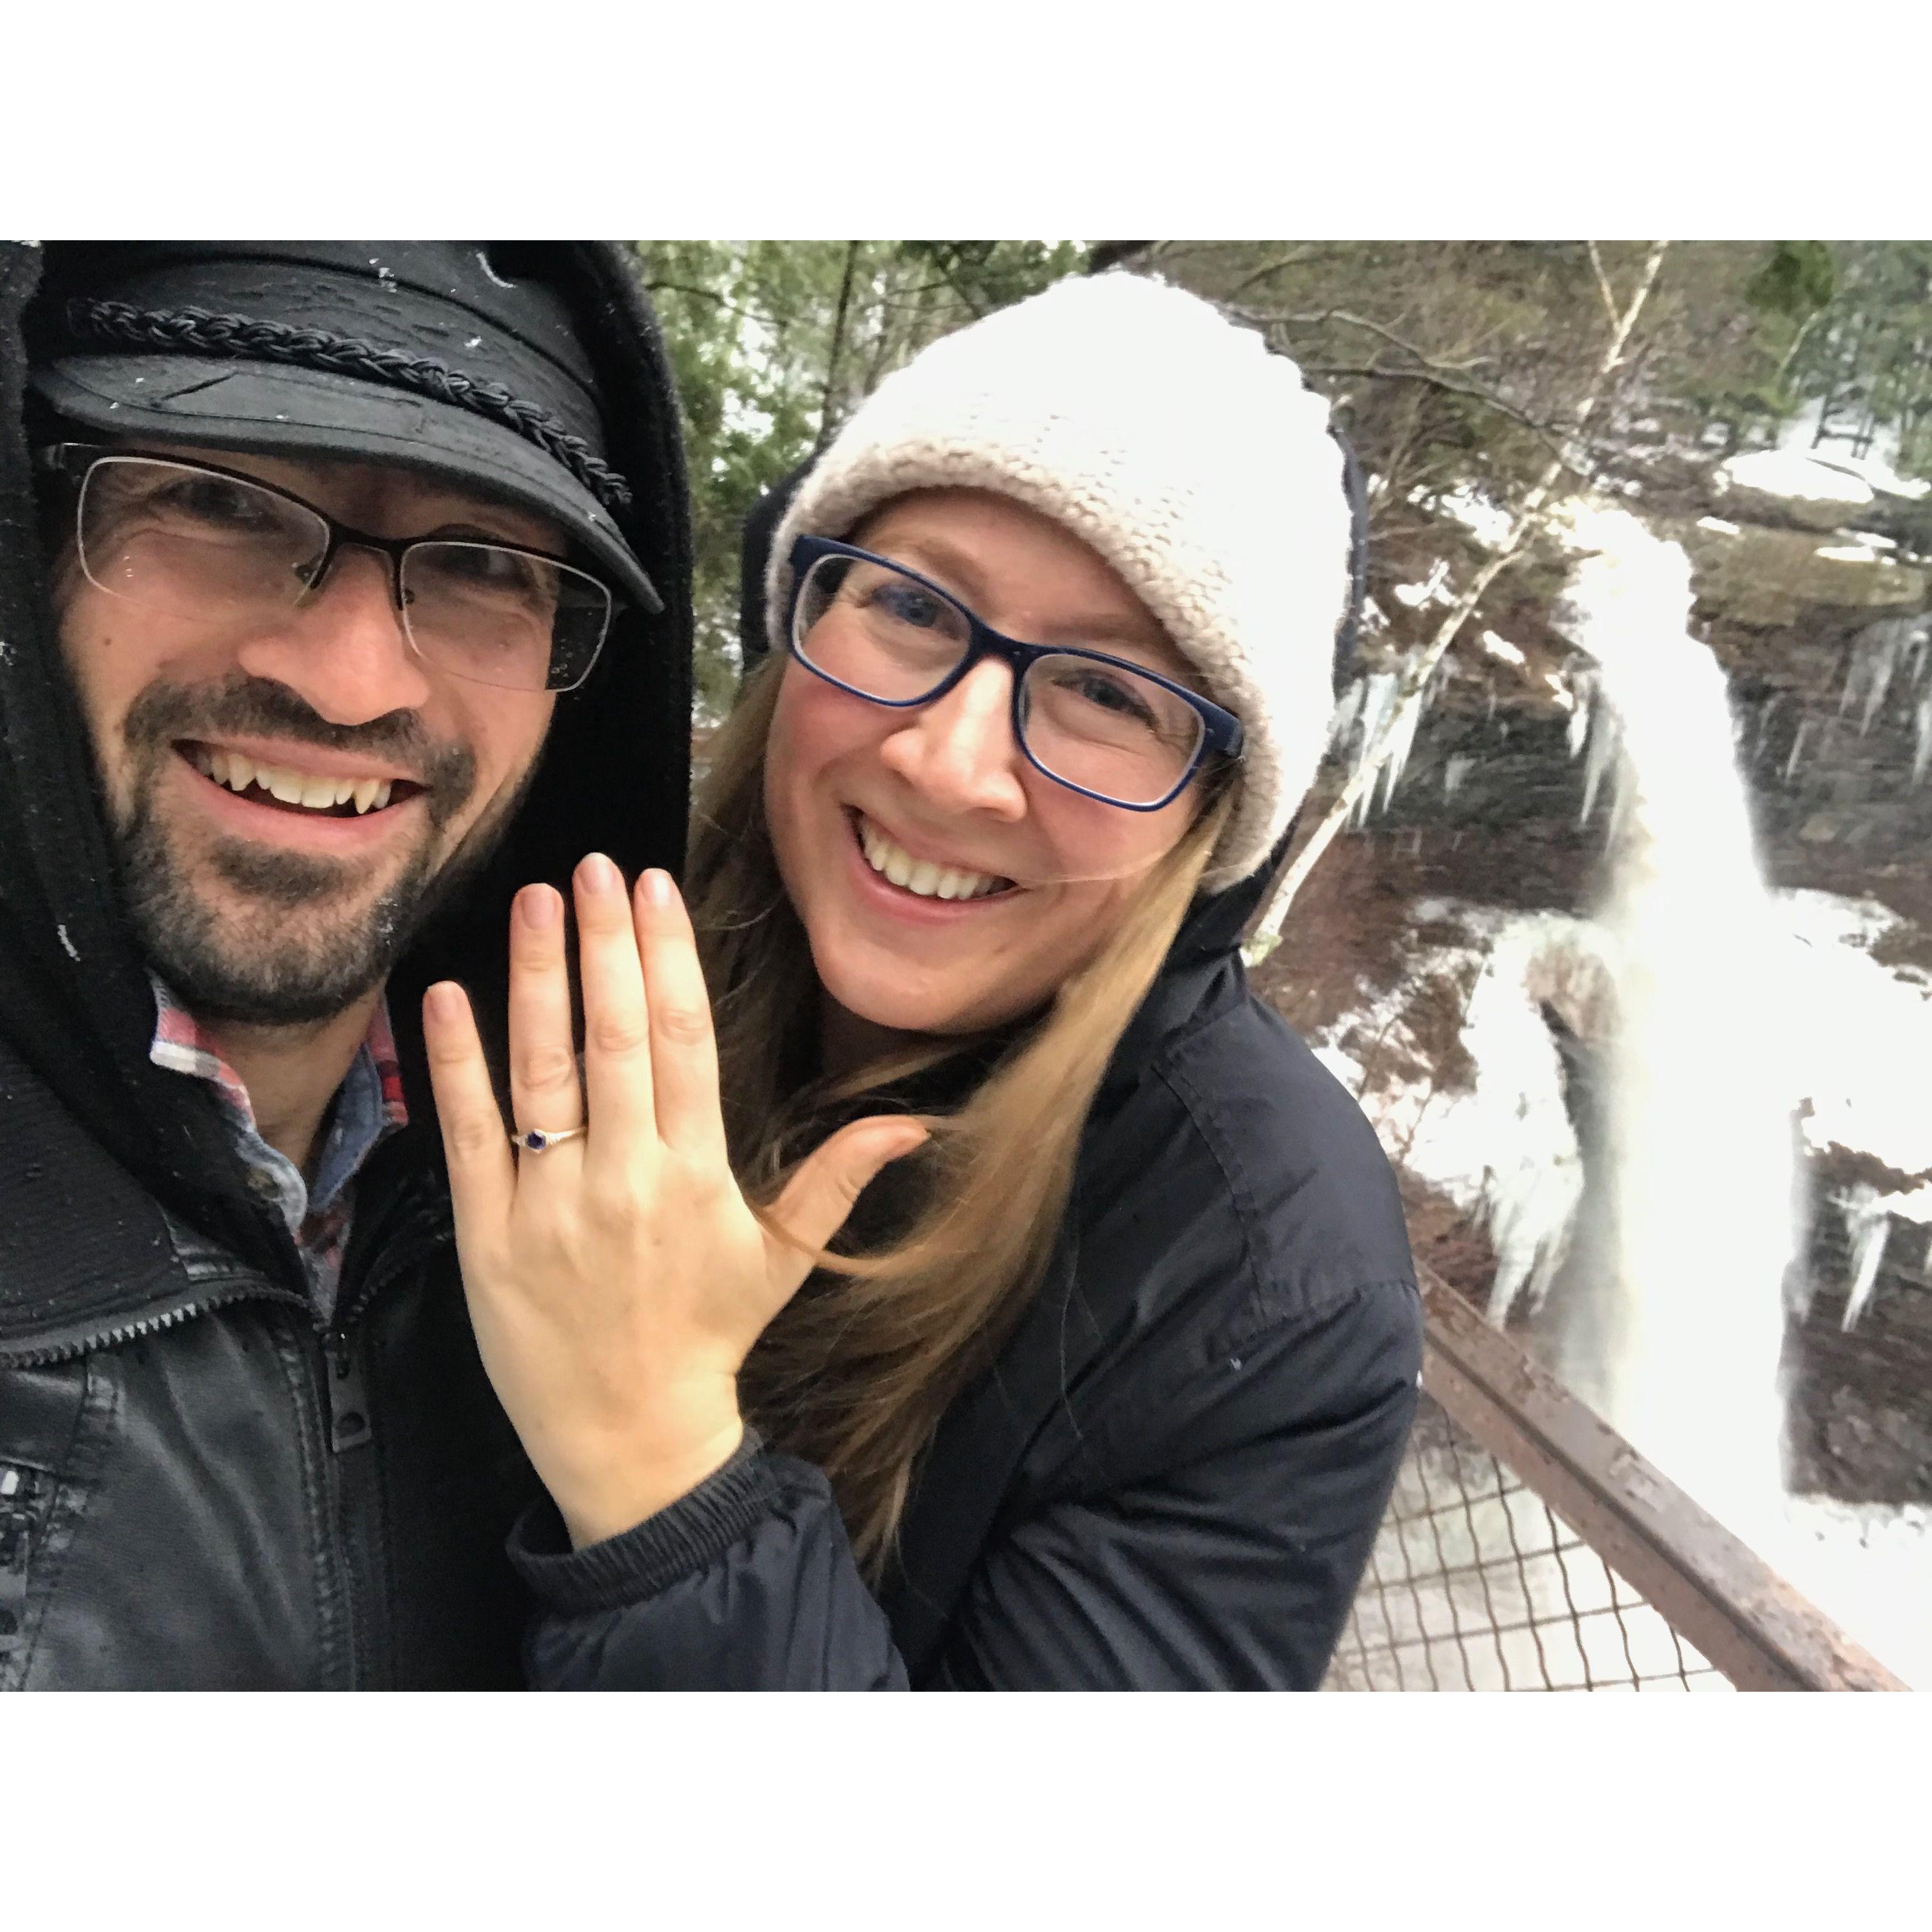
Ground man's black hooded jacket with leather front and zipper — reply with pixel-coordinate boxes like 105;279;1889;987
0;243;689;1689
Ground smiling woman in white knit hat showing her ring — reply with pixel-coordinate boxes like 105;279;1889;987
427;277;1420;1689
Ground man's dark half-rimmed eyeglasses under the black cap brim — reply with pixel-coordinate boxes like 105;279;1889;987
41;442;616;692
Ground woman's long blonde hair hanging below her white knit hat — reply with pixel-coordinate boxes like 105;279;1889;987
686;659;1229;1579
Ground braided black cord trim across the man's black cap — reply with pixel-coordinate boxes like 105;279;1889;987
68;300;632;510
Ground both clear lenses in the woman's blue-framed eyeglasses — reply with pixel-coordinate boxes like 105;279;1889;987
794;556;1204;806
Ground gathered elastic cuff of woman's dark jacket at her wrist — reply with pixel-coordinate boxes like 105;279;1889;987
508;1428;778;1617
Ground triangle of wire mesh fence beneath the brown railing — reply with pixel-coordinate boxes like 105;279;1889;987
1323;1395;1733;1690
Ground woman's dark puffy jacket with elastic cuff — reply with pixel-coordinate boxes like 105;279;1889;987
514;853;1422;1690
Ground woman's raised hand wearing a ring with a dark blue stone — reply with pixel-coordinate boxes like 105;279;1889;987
423;854;925;1545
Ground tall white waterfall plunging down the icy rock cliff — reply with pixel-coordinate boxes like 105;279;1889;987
1538;510;1793;1530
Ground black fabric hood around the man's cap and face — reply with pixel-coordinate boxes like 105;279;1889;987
0;242;692;1273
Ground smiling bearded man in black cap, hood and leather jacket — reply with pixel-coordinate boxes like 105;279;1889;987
0;242;689;1689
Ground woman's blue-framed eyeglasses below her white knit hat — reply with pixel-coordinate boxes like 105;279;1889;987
788;537;1240;811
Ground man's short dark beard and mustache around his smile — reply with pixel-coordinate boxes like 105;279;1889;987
106;676;535;1026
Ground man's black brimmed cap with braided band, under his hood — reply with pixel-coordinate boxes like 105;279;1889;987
29;242;663;613
